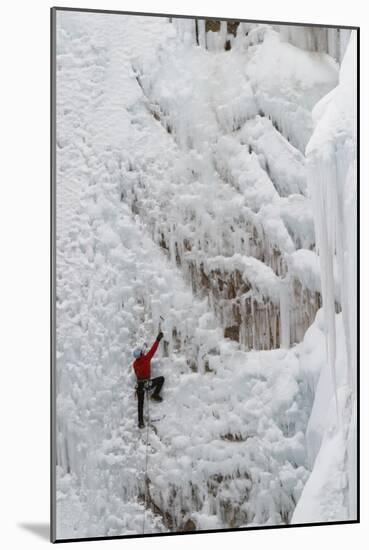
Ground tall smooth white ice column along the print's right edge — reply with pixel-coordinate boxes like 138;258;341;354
294;31;357;522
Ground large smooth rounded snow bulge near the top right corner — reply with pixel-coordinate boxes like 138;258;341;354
243;28;338;153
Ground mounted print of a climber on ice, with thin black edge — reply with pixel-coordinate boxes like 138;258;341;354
51;8;359;542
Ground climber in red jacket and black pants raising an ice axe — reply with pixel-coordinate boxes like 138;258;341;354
133;331;164;428
